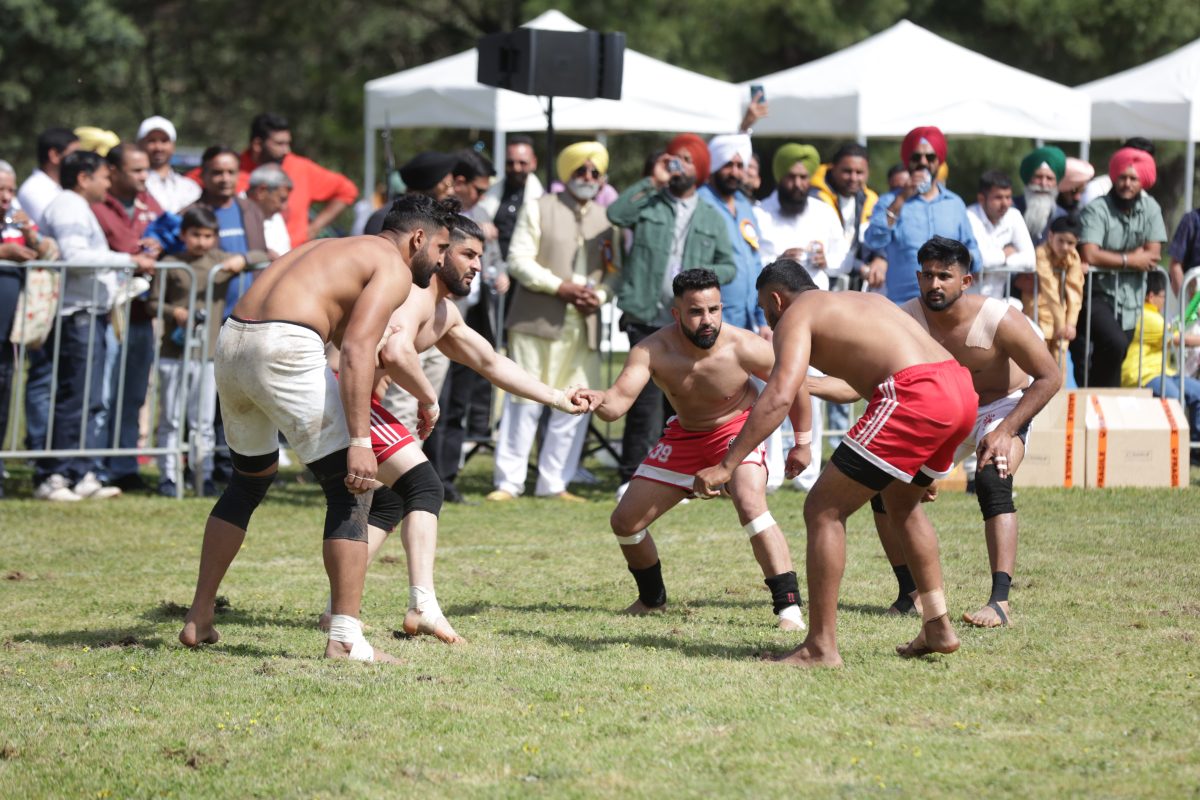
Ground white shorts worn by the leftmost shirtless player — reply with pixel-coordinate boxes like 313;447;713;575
215;317;350;464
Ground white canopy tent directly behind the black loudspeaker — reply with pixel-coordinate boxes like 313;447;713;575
362;11;744;193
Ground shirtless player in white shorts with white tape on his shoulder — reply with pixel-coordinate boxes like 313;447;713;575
854;236;1062;627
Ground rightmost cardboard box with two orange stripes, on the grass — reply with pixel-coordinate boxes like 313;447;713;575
1084;395;1189;488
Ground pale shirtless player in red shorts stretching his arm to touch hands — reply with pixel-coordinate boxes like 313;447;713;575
320;216;589;644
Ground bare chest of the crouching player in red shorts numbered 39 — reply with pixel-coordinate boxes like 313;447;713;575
642;325;775;431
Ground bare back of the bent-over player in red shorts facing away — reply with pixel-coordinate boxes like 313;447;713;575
776;290;953;397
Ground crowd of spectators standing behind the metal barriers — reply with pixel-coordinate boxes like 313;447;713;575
0;102;1200;501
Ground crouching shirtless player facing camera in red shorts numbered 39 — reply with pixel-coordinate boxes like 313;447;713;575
583;270;811;631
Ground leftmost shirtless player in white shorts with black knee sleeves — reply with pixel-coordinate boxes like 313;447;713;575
179;196;456;661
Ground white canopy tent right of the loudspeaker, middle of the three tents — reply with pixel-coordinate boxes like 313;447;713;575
745;19;1090;143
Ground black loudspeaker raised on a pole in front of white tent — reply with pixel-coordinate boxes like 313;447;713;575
478;28;625;100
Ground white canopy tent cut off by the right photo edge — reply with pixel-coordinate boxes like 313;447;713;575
1079;40;1200;209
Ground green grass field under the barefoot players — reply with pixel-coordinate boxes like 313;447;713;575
0;459;1200;798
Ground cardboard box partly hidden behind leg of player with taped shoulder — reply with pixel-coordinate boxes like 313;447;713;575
1014;389;1151;488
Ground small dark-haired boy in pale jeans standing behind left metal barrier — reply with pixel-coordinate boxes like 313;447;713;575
150;205;270;497
